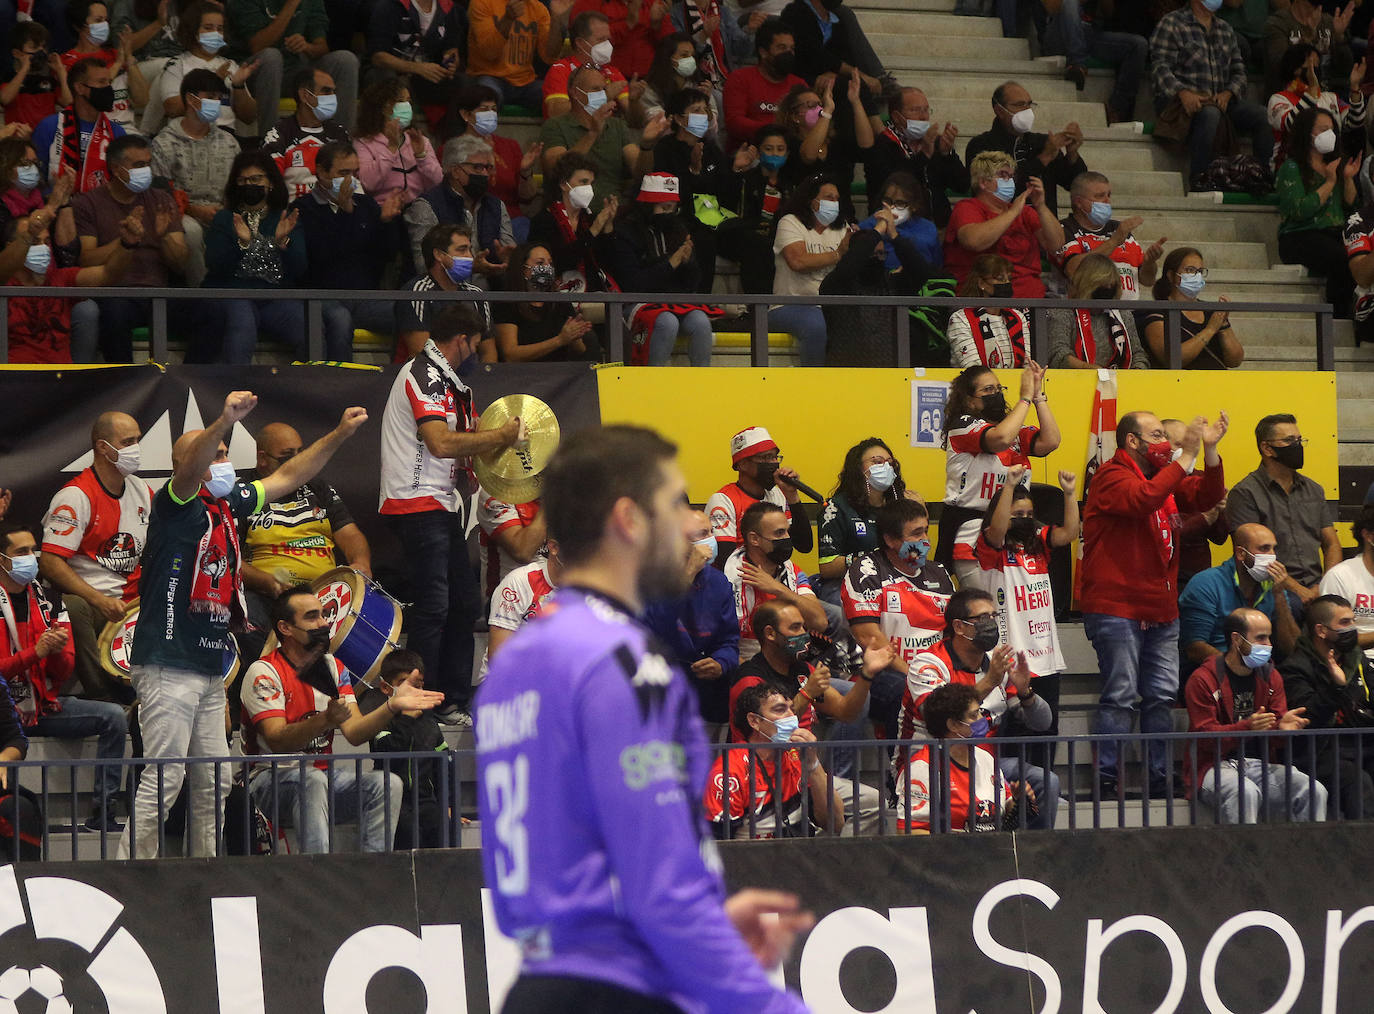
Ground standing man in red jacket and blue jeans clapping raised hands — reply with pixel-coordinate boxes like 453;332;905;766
1077;412;1227;798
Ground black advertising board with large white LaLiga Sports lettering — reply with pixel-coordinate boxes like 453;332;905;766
8;824;1374;1014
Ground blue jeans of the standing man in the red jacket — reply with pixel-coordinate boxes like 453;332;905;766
1083;613;1179;780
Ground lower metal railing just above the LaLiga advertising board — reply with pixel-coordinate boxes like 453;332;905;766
0;730;1374;861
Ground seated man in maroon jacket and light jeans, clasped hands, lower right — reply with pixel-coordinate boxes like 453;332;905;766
1183;607;1326;824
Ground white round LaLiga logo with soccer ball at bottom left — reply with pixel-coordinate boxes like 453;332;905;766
0;866;168;1014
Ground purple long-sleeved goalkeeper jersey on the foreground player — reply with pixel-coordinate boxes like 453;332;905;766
474;588;807;1014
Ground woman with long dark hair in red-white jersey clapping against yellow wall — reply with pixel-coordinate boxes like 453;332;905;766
936;360;1059;588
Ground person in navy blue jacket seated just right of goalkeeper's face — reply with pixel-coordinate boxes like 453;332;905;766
644;511;739;742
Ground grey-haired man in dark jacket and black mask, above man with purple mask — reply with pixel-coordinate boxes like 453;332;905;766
405;135;515;280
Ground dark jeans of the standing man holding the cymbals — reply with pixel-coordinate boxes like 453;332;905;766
387;511;482;712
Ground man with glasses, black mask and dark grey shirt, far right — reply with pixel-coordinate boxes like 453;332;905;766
1226;412;1341;594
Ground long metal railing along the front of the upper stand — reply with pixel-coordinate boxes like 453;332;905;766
0;286;1336;371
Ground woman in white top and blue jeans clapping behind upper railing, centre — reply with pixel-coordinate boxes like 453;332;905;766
768;176;853;367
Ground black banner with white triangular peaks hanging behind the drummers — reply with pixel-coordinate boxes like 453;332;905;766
0;363;600;598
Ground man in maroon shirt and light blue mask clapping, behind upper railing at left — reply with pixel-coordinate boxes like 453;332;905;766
68;135;193;363
